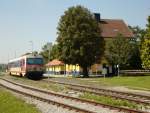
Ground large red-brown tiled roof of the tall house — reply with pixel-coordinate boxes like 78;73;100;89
100;19;133;38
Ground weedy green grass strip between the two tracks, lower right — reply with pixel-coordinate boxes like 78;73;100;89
80;93;141;109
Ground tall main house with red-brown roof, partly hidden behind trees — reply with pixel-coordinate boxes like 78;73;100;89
91;19;134;74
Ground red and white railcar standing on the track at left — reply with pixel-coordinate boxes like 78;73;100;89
8;54;43;79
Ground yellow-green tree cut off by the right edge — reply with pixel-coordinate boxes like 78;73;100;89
141;16;150;69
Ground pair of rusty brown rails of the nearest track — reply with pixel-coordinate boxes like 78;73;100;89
0;78;147;113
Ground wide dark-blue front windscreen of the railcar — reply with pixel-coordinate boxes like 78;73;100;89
27;58;43;65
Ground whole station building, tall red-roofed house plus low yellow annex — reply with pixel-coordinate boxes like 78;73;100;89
46;13;133;74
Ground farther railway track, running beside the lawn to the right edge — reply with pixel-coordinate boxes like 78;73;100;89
43;80;150;106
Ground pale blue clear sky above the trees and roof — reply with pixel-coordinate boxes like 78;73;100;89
0;0;150;63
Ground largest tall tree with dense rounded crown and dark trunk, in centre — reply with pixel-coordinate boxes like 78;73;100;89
57;6;104;77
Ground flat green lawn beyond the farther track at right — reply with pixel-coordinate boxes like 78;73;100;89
80;76;150;90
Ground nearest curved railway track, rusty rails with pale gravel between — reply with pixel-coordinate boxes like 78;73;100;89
0;78;147;113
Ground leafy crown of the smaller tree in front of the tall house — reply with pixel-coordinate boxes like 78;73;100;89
105;34;131;65
